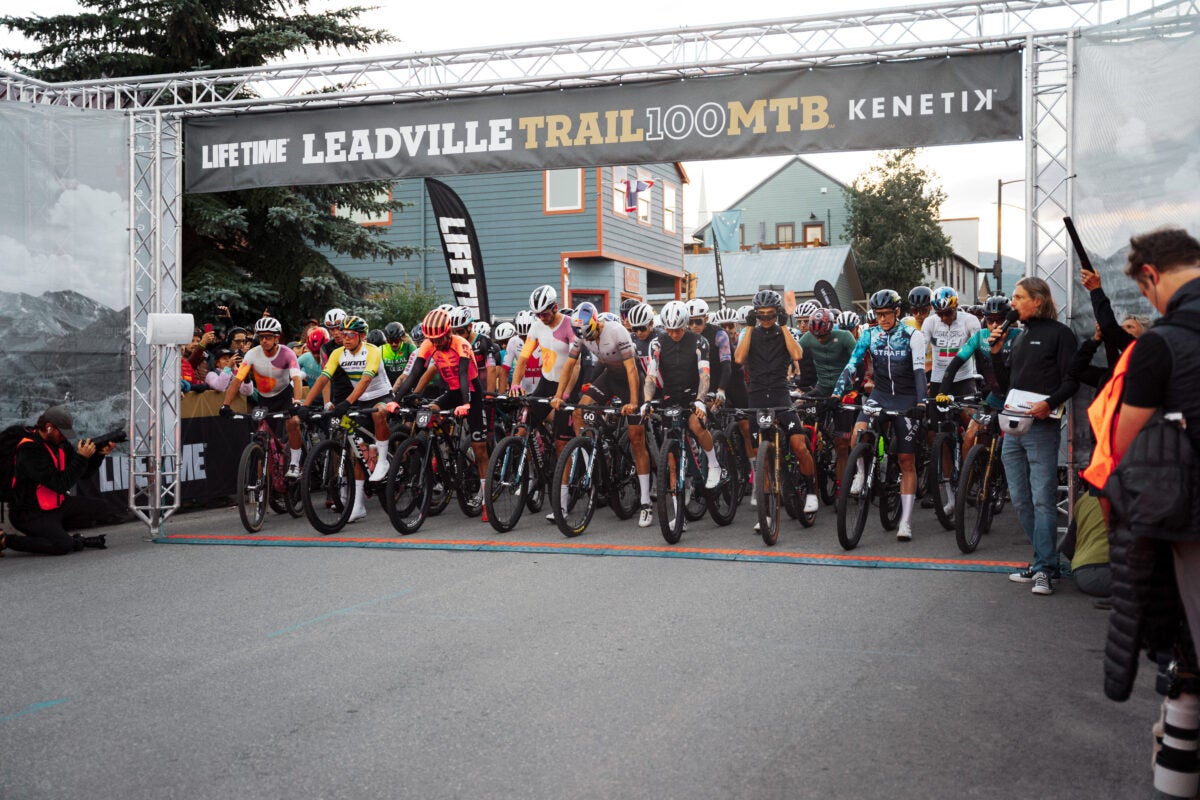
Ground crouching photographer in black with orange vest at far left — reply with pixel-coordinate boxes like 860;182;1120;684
0;405;125;555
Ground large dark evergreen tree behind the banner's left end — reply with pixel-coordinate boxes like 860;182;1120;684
0;0;416;331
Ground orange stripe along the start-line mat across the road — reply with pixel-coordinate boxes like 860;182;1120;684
162;534;1026;569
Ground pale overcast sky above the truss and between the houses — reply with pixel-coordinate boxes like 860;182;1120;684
0;0;1025;257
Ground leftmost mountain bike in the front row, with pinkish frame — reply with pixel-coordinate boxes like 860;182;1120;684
230;405;304;534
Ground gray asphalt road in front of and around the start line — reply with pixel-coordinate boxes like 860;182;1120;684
0;494;1158;800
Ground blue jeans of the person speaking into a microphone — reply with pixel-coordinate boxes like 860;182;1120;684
1001;420;1061;573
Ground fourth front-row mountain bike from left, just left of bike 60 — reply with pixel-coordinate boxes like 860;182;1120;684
484;396;556;534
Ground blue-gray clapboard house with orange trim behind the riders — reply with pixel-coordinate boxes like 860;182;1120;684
330;164;688;317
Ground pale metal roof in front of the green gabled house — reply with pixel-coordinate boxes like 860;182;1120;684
683;245;863;302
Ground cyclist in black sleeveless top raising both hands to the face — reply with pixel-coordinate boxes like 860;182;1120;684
733;289;817;515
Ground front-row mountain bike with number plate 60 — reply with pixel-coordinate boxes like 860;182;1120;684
550;399;638;536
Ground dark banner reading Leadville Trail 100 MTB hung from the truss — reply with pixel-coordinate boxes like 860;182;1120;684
185;50;1021;192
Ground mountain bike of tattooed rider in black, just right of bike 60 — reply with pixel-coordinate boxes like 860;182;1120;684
650;401;739;545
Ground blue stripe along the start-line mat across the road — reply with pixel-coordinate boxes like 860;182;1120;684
154;536;1013;573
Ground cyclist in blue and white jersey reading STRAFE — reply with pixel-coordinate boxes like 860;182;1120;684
834;289;925;542
